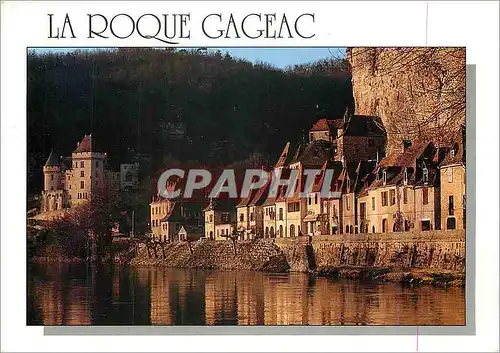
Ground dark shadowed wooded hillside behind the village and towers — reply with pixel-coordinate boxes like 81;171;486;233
27;49;352;192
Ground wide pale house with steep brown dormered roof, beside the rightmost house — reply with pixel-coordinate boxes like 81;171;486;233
359;140;440;233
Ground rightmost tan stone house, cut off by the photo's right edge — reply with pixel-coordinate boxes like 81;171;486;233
439;127;466;230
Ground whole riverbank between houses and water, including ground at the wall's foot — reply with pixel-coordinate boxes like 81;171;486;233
32;232;465;287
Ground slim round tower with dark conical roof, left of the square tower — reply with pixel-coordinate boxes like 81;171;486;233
42;151;65;212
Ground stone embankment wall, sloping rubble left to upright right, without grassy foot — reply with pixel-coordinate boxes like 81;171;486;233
127;231;465;272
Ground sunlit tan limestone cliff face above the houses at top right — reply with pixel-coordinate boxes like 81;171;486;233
347;48;465;154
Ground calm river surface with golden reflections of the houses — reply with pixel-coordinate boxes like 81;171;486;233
27;264;465;325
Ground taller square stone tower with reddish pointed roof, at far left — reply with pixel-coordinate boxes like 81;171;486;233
67;135;106;207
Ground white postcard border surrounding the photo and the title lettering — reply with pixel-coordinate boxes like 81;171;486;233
1;1;499;351
